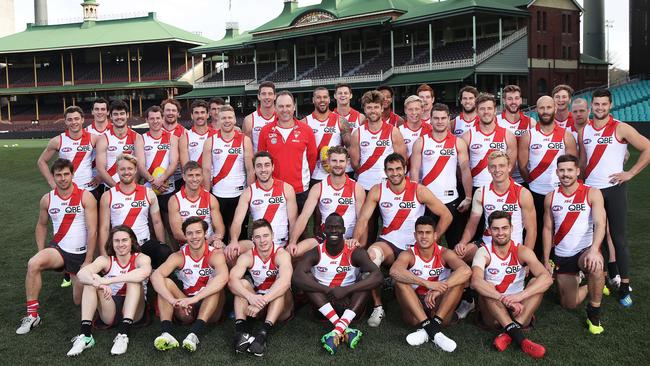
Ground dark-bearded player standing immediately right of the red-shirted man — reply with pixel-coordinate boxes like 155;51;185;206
301;87;351;186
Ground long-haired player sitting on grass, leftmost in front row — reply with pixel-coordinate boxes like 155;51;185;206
68;225;151;356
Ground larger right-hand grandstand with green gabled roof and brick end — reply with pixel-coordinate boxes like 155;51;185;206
179;0;607;113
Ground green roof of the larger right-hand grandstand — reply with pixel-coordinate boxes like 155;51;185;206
192;0;530;53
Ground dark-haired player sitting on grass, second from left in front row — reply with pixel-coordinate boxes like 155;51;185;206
151;216;228;352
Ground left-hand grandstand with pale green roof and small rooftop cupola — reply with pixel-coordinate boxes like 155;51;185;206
0;0;211;131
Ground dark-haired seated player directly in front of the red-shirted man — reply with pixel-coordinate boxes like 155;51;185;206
225;151;298;262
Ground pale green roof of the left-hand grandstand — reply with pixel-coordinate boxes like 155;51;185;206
0;13;211;54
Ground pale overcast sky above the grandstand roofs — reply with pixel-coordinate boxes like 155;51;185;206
14;0;629;70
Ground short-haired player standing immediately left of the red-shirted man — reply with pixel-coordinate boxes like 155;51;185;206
201;105;255;243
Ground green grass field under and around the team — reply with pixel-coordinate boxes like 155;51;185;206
0;140;650;366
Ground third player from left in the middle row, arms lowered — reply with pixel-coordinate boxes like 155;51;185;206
169;160;226;249
